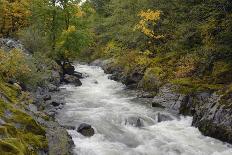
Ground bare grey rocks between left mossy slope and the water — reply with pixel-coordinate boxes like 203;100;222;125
32;61;85;155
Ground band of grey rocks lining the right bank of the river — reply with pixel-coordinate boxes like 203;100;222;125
91;60;232;144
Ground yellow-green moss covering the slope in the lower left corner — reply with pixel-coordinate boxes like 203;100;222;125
0;81;48;155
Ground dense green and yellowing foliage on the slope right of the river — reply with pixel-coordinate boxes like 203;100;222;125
87;0;232;92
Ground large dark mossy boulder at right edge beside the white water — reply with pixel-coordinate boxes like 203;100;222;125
187;92;232;144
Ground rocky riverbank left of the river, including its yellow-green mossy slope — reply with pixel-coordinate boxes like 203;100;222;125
0;39;82;155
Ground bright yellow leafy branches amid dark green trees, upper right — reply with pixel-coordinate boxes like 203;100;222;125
134;9;164;39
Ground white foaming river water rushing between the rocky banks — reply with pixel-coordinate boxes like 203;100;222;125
57;65;232;155
